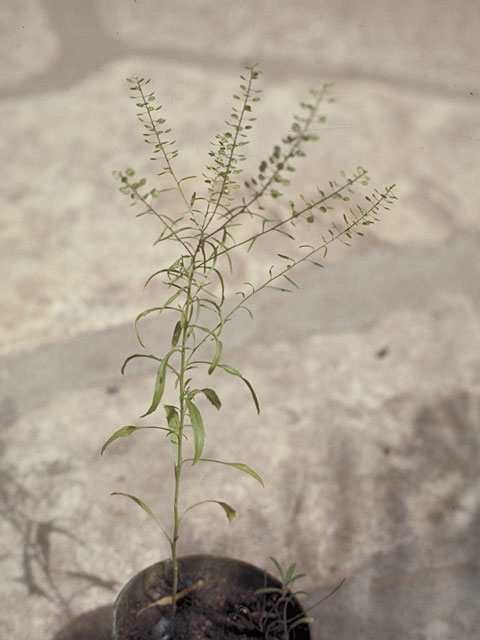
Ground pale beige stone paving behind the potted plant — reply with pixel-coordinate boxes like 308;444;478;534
0;0;480;640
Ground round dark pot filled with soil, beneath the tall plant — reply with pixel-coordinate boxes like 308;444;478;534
113;556;310;640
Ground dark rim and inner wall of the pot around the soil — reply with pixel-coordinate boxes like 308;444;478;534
112;555;310;640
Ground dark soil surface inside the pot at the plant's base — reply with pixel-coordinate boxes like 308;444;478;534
121;576;309;640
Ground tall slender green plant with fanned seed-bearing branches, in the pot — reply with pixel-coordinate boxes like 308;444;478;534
102;65;395;611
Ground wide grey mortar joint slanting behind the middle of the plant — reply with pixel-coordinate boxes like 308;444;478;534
0;234;480;412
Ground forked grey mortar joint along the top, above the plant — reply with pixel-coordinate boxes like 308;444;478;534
0;0;478;101
